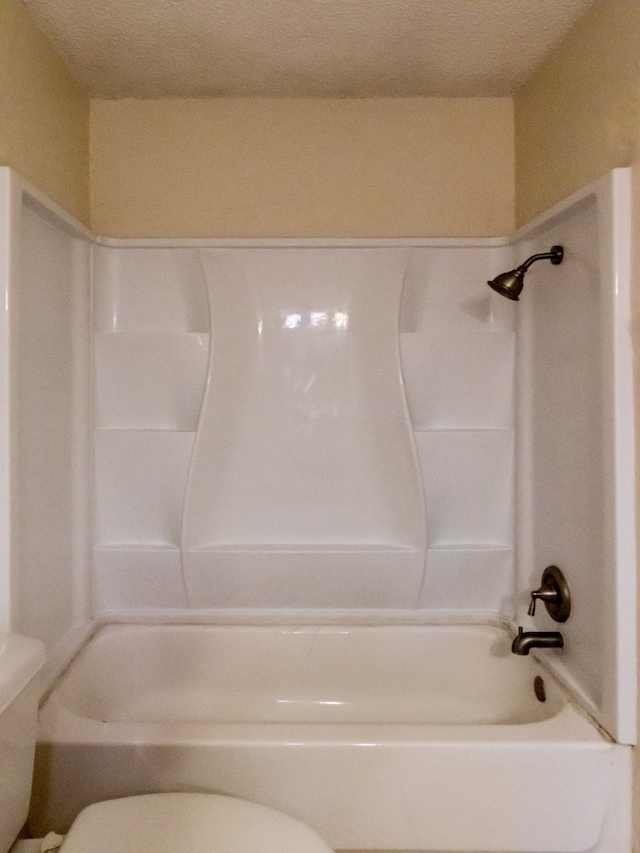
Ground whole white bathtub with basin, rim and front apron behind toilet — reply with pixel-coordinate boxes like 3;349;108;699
30;625;629;853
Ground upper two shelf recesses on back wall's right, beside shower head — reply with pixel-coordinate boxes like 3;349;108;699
400;247;515;431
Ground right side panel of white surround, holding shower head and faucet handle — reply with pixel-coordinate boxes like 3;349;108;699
517;170;636;743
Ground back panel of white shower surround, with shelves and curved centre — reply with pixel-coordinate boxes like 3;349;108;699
94;246;515;616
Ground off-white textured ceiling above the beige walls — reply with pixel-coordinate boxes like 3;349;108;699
25;0;593;98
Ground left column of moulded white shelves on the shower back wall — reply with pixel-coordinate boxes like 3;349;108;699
93;246;209;612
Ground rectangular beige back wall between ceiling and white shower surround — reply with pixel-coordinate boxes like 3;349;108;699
91;98;514;237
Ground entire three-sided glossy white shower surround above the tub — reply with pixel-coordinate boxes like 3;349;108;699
0;163;635;741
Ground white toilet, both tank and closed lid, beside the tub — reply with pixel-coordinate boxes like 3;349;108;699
0;634;331;853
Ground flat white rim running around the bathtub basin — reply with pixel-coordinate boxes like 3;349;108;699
38;614;615;745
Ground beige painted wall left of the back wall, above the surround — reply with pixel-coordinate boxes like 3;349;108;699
0;0;89;224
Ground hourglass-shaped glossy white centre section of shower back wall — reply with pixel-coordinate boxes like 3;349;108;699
183;249;425;607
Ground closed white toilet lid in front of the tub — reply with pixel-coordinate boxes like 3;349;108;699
60;794;332;853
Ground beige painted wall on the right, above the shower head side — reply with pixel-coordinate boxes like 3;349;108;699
515;0;640;850
